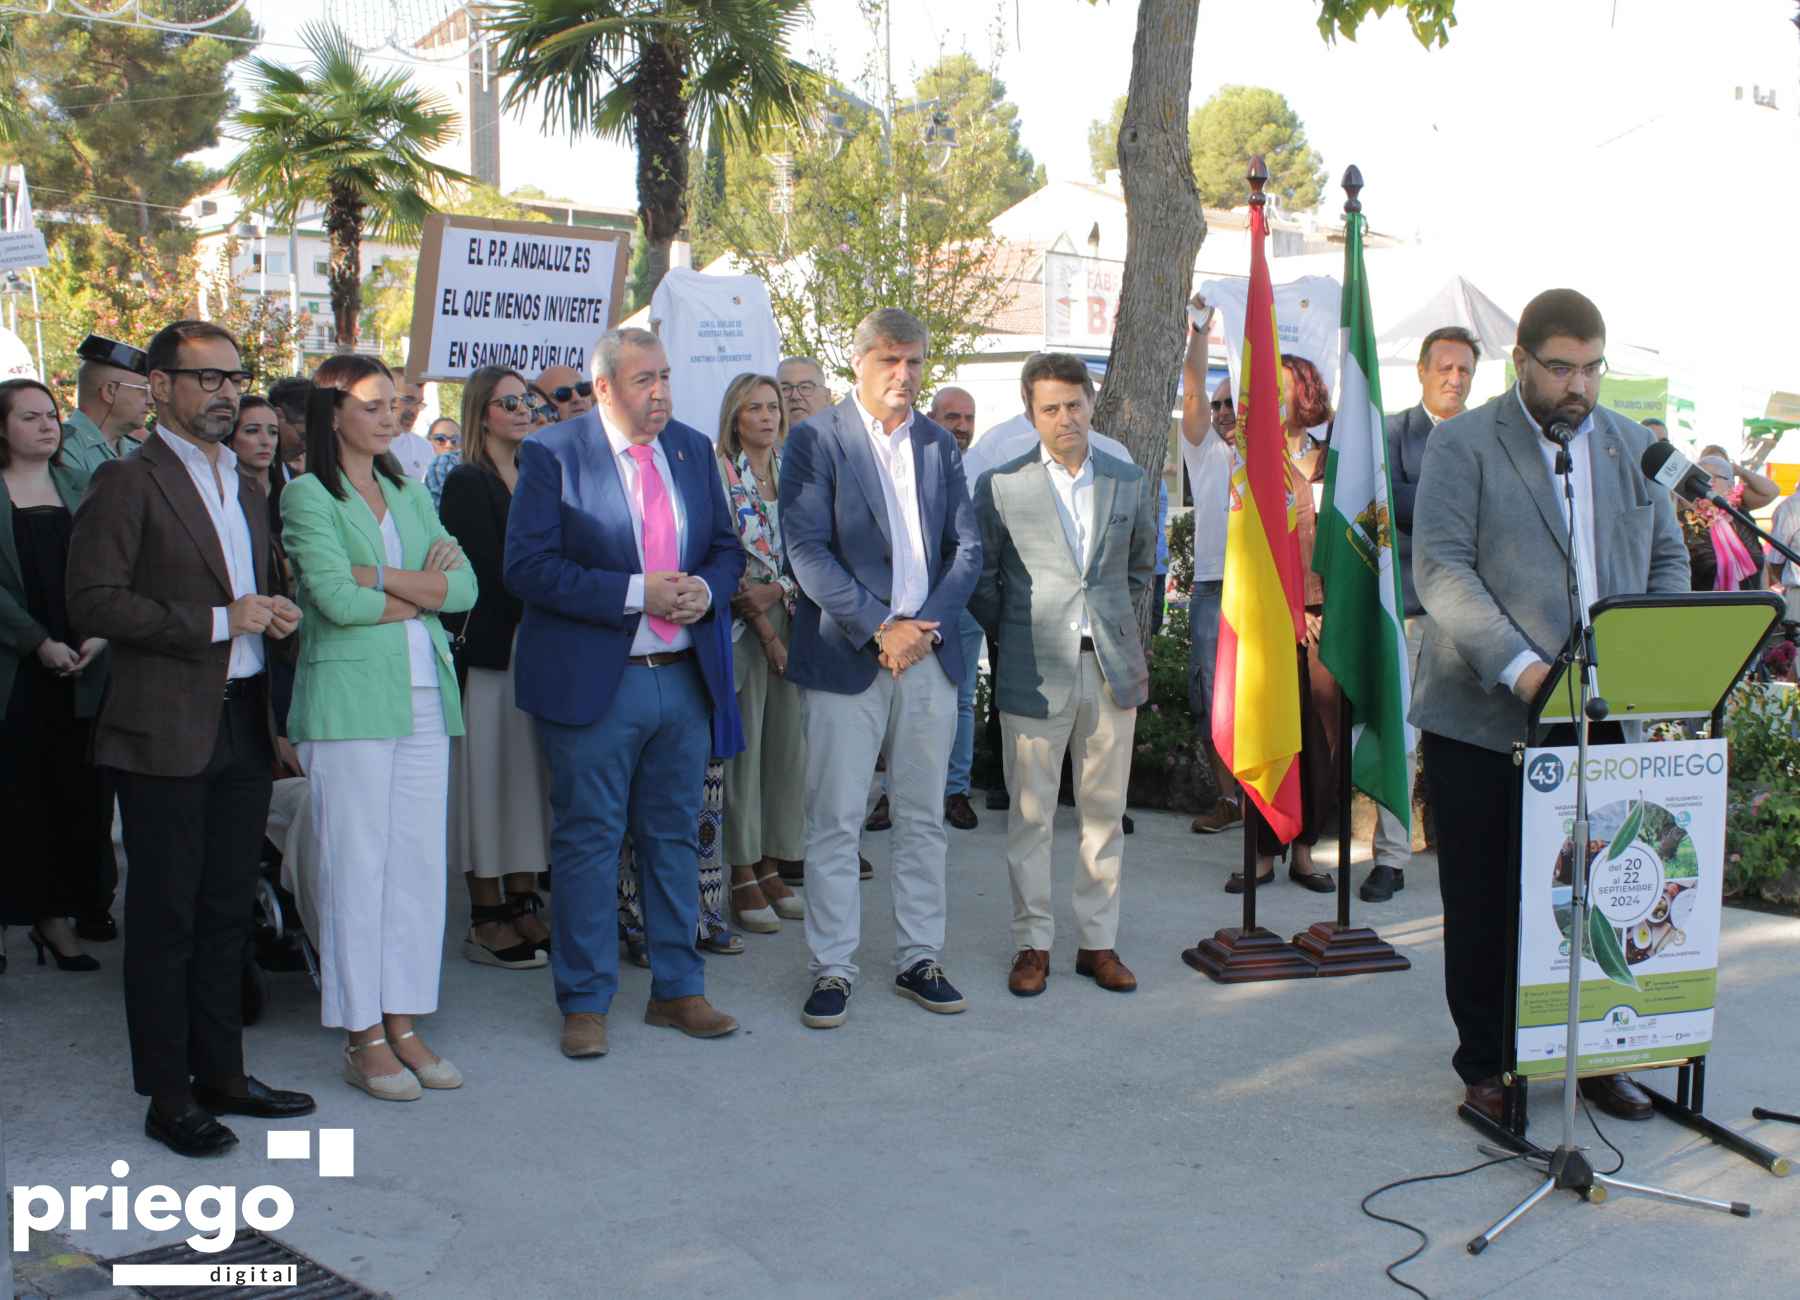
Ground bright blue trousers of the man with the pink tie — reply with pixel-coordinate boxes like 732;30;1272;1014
536;659;713;1016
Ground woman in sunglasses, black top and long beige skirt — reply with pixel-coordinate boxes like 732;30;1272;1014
441;366;551;970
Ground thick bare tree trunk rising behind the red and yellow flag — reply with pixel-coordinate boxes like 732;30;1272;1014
1094;0;1206;643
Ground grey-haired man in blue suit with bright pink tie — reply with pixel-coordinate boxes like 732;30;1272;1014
506;330;743;1057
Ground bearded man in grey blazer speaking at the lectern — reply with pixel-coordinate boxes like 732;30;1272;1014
1411;288;1688;1122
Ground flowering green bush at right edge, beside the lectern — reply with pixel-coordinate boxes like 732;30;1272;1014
1724;682;1800;895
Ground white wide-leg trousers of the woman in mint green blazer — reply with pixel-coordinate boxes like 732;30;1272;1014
299;686;450;1030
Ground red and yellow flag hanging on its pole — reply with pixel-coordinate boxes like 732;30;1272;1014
1213;192;1305;843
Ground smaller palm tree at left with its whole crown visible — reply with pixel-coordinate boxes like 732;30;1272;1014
225;23;468;351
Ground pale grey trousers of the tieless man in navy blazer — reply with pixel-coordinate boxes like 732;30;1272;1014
801;654;956;981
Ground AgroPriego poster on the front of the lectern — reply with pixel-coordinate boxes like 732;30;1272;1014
1516;740;1726;1077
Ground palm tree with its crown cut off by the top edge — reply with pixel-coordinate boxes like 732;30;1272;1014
482;0;824;290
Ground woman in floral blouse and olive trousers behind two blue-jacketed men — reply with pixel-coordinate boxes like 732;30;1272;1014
718;375;806;934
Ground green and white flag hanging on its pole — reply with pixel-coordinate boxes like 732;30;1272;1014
1312;202;1411;826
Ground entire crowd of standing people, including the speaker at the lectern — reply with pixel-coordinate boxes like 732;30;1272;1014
0;290;1771;1156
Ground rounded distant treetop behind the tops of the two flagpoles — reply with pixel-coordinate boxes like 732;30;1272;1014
1188;86;1325;212
